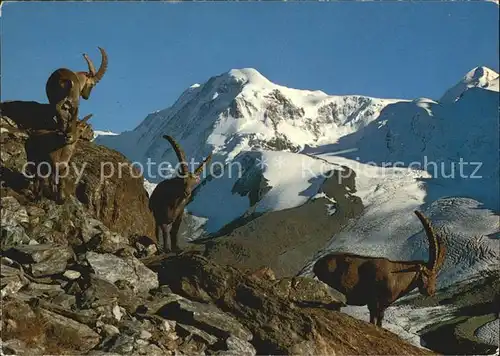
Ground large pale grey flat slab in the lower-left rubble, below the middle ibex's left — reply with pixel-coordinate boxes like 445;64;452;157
86;252;158;293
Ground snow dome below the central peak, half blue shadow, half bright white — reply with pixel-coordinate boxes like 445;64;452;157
187;151;337;233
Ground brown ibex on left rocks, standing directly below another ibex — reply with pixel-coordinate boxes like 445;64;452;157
25;114;92;203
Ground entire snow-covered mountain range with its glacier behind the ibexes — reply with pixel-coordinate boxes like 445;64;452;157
96;67;500;344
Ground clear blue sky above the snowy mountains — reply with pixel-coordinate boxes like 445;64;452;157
1;2;499;132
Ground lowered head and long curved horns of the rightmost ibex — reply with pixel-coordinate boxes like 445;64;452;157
415;210;446;296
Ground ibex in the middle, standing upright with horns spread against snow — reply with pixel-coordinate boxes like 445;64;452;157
149;135;212;252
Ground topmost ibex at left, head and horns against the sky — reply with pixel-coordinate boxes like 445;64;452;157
45;47;108;129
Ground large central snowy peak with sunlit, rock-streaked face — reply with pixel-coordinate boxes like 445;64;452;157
96;68;398;182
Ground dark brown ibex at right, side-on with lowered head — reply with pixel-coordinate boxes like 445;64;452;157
313;211;445;326
